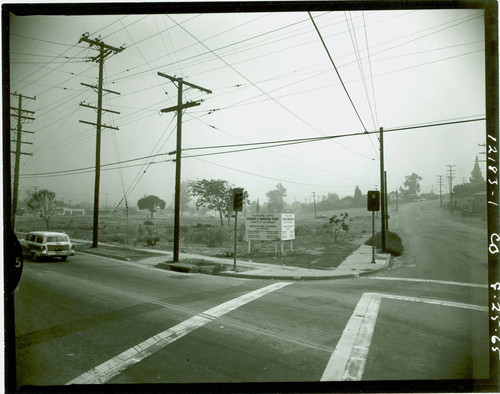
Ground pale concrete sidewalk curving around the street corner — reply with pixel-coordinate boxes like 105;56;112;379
75;240;391;280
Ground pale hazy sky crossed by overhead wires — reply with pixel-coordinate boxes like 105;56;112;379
6;4;485;206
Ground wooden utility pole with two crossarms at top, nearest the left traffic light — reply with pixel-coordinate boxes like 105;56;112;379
158;72;212;263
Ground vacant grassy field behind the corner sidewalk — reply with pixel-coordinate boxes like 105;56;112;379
16;208;380;269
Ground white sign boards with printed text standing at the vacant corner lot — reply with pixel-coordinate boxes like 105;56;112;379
245;213;295;241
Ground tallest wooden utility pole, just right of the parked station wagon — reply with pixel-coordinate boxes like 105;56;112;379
78;33;124;248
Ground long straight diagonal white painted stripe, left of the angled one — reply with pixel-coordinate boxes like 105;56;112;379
66;282;293;385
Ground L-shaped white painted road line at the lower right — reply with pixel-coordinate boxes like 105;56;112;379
321;293;488;381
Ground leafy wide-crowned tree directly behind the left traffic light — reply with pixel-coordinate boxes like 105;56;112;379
189;179;234;227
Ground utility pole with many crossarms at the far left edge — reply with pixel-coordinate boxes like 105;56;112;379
10;93;36;231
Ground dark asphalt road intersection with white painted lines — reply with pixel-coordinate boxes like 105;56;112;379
11;201;488;386
